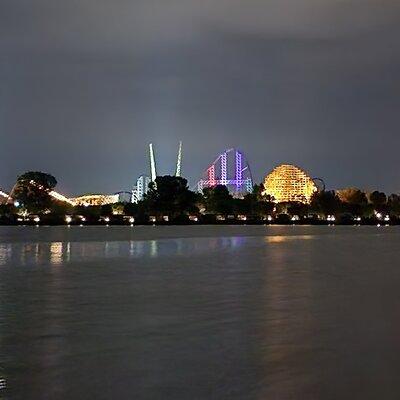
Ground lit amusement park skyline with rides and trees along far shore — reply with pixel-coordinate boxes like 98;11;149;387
0;142;400;225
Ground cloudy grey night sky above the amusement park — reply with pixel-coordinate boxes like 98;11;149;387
0;0;400;195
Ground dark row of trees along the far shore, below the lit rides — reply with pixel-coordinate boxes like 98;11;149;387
0;172;400;223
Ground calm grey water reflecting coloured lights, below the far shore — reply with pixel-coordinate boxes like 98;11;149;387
0;227;400;400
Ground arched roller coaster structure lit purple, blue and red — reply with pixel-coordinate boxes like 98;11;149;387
197;149;253;197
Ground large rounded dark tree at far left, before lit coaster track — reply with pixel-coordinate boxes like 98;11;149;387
12;171;57;213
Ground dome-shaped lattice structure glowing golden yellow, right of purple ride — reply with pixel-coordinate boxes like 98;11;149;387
264;164;317;203
